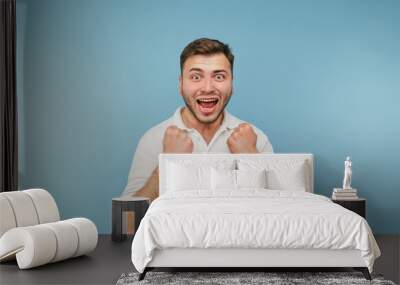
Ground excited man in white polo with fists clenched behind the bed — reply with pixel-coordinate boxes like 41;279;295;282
122;38;273;200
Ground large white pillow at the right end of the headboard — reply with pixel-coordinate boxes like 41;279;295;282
238;159;311;191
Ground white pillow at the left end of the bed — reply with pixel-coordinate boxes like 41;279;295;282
166;162;211;191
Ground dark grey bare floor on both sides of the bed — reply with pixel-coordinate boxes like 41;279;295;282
0;235;400;285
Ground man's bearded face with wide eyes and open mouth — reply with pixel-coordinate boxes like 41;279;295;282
179;53;233;124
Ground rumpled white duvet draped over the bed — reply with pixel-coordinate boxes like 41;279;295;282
132;189;380;272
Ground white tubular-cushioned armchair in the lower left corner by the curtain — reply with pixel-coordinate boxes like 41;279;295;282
0;189;98;269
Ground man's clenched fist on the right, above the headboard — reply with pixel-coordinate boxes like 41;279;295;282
226;123;258;153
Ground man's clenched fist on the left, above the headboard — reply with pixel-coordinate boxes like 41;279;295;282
163;125;193;153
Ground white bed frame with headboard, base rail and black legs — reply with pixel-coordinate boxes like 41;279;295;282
139;153;371;280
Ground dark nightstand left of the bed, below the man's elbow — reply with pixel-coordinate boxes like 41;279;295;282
111;196;150;241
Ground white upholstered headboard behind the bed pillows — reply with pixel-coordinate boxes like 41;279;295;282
159;153;314;195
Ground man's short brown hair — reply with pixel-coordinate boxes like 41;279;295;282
181;38;235;74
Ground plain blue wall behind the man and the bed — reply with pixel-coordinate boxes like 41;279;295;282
17;0;400;234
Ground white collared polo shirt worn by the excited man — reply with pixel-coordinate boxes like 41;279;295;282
121;106;273;196
